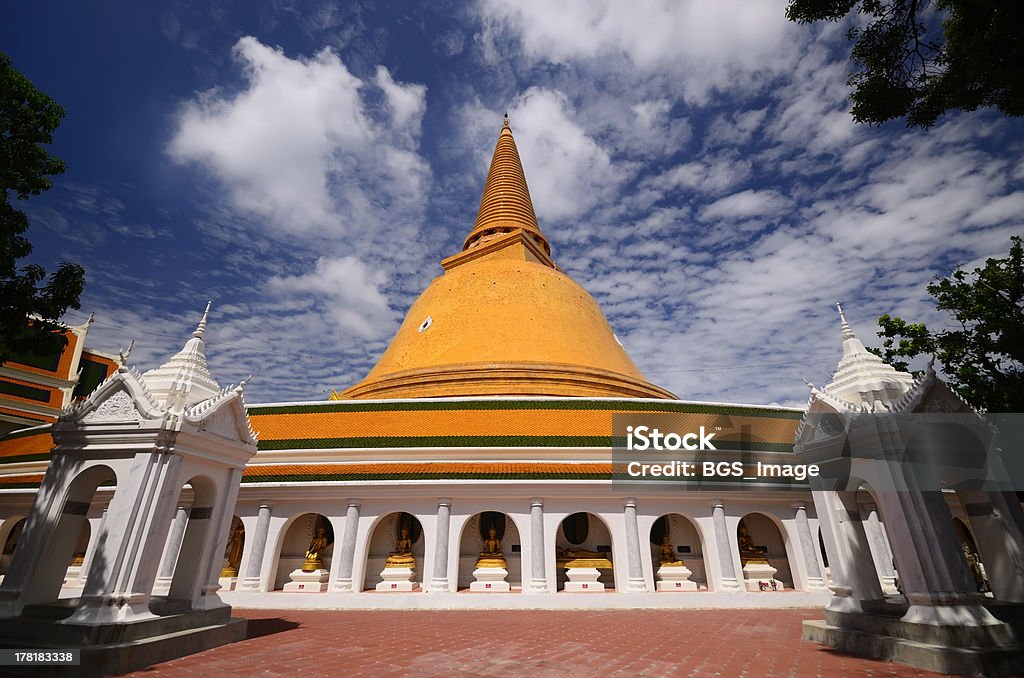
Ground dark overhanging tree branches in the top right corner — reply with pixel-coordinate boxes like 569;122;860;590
785;0;1024;127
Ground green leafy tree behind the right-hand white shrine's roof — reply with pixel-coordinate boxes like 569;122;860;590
877;236;1024;413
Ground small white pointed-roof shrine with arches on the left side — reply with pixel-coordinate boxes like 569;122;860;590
0;306;256;674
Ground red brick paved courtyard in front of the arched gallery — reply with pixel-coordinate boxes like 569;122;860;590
132;609;937;678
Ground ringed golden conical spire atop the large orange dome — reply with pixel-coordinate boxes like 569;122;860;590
463;113;551;254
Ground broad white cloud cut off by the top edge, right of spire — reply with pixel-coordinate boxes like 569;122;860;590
476;0;801;101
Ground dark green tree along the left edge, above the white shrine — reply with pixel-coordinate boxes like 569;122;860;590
0;53;85;365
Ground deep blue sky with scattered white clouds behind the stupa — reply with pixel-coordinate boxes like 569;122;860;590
0;0;1024;406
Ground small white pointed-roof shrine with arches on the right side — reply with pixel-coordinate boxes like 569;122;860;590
795;309;1024;675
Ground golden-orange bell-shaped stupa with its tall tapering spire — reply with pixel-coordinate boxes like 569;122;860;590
332;117;675;399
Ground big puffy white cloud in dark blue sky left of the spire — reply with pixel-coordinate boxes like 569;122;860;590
168;37;429;246
